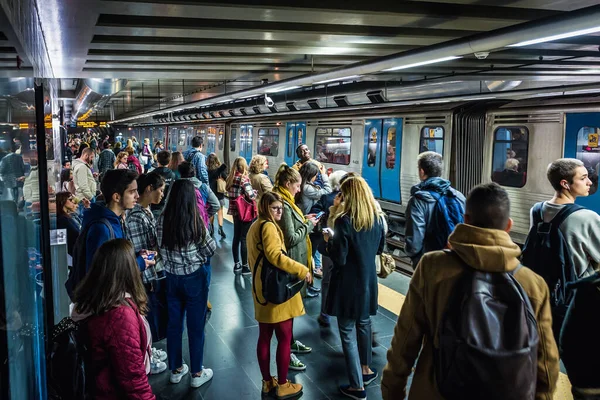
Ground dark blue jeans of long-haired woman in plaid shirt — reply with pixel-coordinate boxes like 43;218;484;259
166;266;211;374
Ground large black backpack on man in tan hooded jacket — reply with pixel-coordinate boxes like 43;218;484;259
434;252;539;400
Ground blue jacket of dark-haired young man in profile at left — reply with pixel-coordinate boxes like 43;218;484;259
81;202;146;271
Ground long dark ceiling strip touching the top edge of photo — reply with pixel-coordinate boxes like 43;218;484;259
117;0;561;21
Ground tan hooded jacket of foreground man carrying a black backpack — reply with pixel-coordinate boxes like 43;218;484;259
381;224;559;400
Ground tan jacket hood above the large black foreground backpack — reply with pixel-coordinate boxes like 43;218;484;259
448;224;521;272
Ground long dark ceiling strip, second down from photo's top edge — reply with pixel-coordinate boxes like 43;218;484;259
96;14;479;39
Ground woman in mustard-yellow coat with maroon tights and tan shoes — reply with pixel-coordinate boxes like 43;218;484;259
247;192;312;400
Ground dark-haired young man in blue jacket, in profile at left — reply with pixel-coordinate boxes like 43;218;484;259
81;169;154;271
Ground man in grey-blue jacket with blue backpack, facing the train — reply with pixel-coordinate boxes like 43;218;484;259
404;151;465;268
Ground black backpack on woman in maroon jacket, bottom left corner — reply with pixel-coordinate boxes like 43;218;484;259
48;318;93;400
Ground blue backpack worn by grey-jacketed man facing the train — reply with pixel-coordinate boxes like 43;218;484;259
425;190;465;250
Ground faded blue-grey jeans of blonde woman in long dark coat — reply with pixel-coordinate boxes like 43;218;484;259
337;317;372;389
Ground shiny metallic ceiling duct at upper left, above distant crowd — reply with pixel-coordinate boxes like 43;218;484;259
71;78;127;121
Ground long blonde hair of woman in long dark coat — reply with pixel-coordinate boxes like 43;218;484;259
340;176;377;232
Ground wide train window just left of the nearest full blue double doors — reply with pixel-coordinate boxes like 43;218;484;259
315;128;352;165
